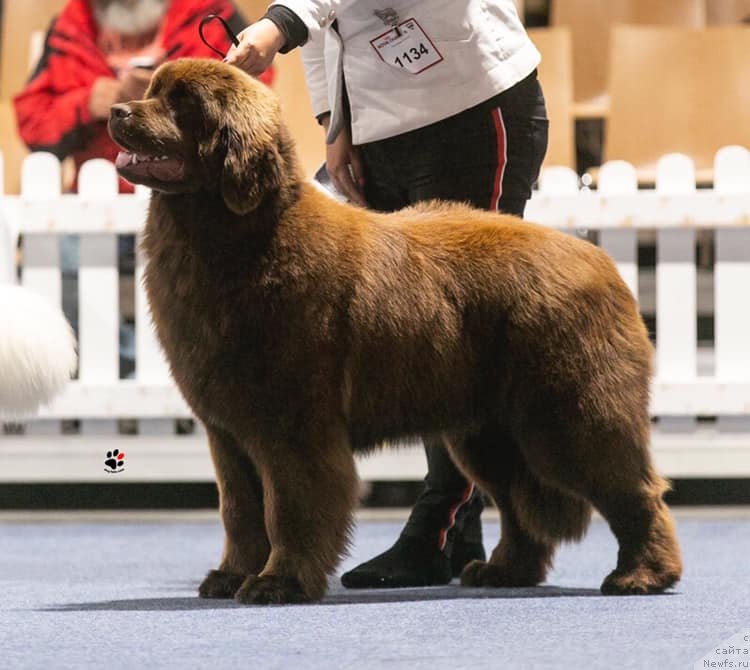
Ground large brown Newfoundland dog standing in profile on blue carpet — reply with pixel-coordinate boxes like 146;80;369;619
110;60;681;603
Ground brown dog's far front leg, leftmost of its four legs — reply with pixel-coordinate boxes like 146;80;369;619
198;425;270;598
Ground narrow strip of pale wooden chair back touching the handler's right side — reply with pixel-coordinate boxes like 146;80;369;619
529;28;575;168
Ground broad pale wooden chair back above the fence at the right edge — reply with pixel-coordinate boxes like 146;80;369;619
605;26;750;175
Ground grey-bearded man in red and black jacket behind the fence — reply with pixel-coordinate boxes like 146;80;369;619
14;0;272;192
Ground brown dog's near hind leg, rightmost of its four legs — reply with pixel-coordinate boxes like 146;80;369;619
522;408;682;595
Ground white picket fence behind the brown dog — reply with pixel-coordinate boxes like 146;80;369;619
0;147;750;482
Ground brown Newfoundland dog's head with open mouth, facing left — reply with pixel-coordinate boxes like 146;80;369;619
109;59;294;214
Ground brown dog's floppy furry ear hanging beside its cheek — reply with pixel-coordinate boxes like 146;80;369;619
220;119;283;214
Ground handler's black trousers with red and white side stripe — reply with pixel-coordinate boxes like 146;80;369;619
360;71;548;534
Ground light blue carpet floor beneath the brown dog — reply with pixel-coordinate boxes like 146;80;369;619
0;513;750;670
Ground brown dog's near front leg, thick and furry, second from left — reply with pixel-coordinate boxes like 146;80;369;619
235;421;358;604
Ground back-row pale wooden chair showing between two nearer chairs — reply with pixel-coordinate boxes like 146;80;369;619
551;0;706;117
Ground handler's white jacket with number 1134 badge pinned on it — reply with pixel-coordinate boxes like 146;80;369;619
273;0;541;144
